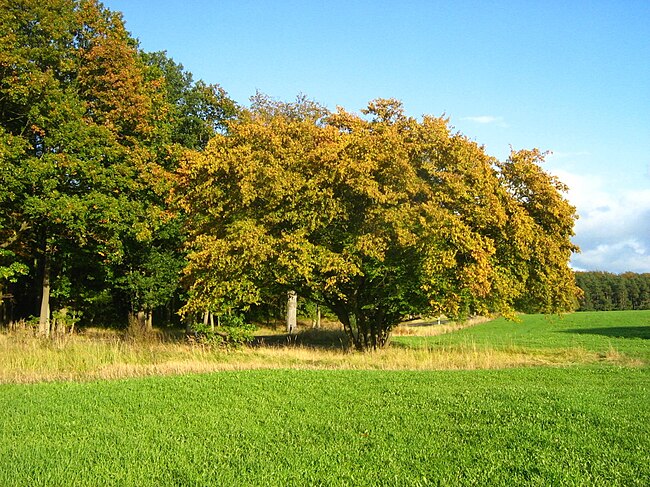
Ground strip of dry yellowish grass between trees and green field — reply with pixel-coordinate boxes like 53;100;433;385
0;324;640;383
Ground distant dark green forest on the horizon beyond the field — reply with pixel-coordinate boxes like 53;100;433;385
576;272;650;311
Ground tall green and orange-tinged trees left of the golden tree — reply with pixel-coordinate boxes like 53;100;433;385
0;0;235;333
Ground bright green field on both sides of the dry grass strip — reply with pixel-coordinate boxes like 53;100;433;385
0;312;650;486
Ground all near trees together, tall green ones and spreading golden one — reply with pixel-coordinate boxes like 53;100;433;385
0;0;578;350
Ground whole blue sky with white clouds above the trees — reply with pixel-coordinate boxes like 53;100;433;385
104;0;650;272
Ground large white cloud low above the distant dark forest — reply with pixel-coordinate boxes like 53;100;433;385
553;170;650;273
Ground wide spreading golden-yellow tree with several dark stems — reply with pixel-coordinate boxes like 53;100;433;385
176;95;577;350
